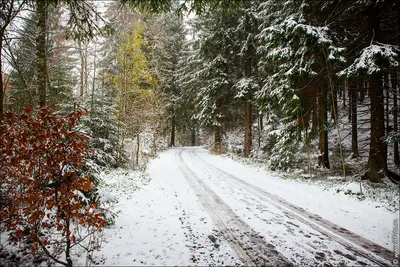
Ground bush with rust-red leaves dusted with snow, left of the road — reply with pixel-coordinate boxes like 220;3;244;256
0;108;104;266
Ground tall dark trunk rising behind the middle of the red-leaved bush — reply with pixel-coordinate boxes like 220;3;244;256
36;0;48;107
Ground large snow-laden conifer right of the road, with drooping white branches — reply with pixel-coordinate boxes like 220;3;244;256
258;1;343;168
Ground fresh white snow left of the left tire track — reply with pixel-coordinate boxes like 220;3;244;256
79;150;240;266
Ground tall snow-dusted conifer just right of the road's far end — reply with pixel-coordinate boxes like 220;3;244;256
188;9;239;152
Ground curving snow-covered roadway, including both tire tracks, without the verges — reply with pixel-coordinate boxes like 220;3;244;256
175;147;393;266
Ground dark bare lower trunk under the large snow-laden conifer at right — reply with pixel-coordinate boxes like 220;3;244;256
318;86;330;169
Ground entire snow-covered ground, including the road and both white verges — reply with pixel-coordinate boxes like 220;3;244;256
83;147;398;266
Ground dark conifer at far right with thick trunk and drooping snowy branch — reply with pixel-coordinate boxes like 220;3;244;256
340;1;400;182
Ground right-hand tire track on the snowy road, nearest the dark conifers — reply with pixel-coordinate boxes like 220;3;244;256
188;149;393;266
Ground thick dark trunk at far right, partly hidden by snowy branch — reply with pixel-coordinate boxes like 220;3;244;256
367;5;387;182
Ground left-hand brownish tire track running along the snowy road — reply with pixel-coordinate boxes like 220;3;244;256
176;151;291;266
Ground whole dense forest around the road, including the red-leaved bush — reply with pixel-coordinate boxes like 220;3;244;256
0;0;400;266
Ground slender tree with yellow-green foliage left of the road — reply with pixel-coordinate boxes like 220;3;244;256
113;22;160;164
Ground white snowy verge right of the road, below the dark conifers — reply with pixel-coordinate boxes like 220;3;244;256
200;151;399;249
